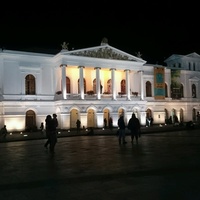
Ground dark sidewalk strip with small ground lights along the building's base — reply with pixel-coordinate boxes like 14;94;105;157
0;122;200;143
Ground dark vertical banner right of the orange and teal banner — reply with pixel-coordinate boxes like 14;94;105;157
171;69;181;99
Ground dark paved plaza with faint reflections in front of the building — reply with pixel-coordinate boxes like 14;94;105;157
0;129;200;200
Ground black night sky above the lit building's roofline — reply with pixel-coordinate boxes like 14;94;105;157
0;0;200;64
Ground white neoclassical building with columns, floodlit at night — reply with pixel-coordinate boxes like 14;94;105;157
0;39;200;131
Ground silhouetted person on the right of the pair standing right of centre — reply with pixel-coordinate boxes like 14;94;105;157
128;113;140;143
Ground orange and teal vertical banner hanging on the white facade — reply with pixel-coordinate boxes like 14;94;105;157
154;67;165;99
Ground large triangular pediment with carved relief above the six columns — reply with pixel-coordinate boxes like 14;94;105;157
61;44;146;63
